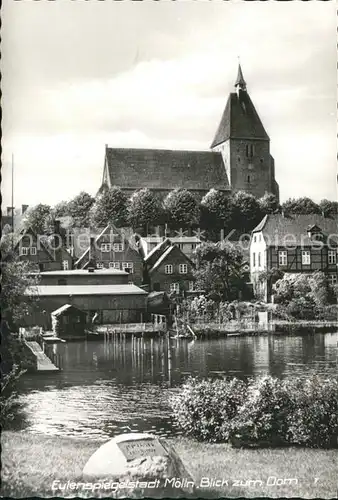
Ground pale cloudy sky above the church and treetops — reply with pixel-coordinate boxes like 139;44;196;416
2;0;337;207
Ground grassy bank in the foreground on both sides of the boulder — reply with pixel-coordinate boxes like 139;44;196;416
1;432;337;498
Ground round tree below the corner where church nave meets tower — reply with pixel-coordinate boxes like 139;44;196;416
201;189;233;236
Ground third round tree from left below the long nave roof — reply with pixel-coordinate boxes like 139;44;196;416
163;189;199;228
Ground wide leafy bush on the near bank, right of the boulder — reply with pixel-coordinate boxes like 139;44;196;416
171;375;338;448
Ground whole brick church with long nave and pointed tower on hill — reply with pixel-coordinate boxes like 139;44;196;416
100;65;279;198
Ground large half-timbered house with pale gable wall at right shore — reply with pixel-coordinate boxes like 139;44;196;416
250;213;338;301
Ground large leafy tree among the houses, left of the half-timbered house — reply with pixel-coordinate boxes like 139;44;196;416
194;243;245;300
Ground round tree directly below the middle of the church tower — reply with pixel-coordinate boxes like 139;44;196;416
230;191;263;232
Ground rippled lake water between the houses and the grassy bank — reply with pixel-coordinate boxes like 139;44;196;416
19;333;338;440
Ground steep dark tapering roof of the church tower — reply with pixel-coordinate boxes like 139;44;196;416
211;90;269;148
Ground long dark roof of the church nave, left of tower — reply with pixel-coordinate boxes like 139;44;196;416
106;148;229;190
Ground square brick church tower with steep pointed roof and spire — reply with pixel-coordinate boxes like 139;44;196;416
211;65;279;199
